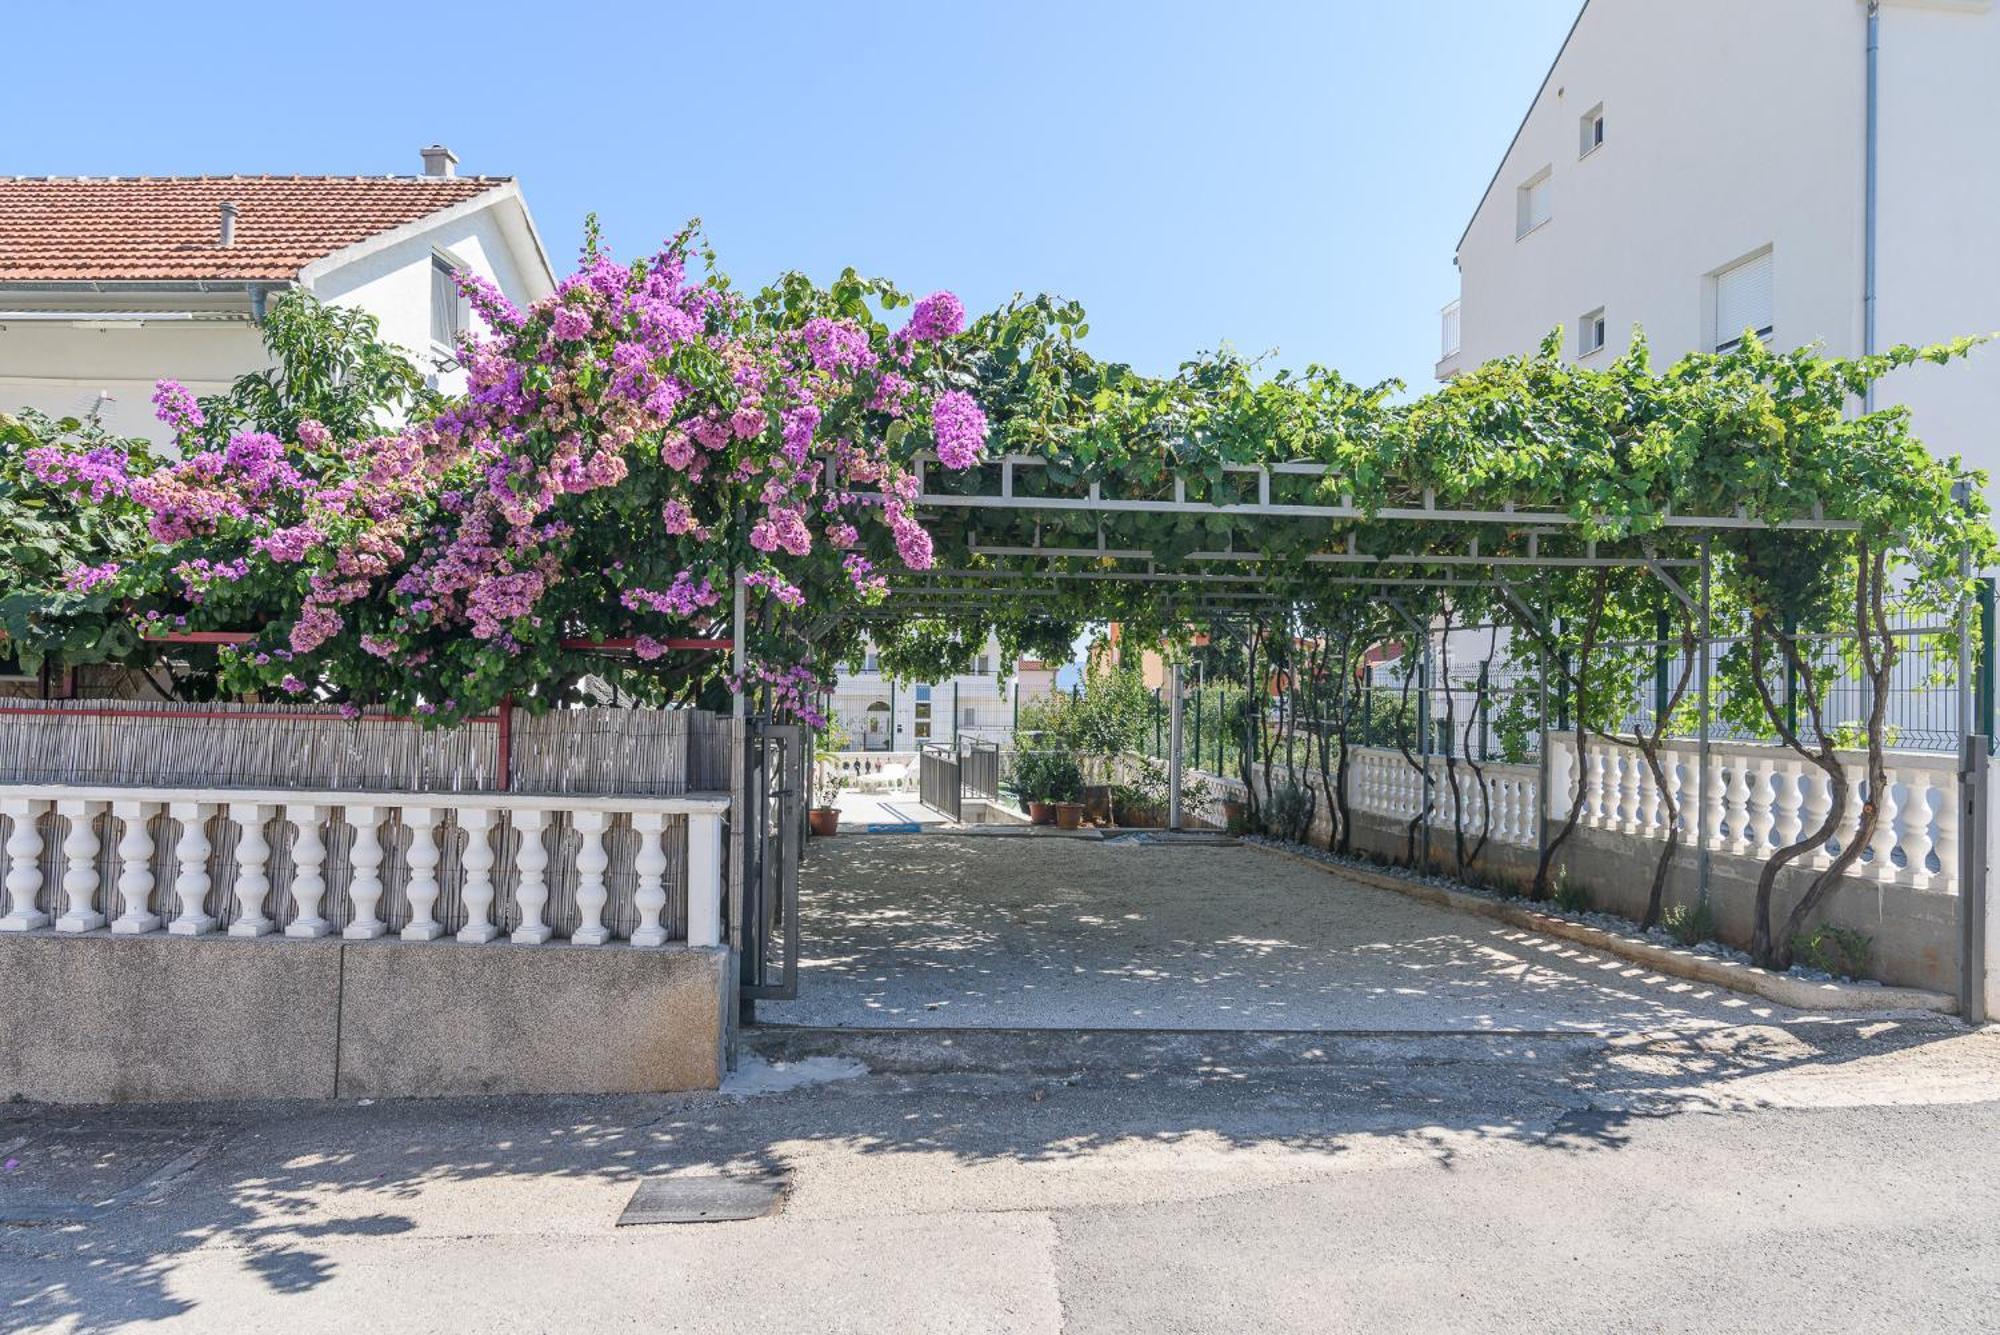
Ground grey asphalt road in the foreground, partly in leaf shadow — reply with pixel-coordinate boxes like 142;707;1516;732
0;1017;2000;1335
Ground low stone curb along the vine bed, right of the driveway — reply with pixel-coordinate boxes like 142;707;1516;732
1244;843;1958;1015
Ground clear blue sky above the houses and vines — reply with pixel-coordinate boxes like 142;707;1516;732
15;0;1578;388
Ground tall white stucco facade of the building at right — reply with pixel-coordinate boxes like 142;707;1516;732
1438;0;2000;498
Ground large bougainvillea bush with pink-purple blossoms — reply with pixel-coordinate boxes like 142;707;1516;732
13;234;986;721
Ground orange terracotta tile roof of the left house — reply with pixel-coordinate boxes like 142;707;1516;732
0;176;512;282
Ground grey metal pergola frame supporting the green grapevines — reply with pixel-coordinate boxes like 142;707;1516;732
756;454;1986;1019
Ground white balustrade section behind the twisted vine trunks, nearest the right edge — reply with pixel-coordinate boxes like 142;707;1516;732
1548;735;1958;893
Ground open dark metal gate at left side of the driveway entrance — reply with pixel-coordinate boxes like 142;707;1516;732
738;719;812;1001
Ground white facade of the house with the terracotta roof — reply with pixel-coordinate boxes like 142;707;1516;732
0;171;554;442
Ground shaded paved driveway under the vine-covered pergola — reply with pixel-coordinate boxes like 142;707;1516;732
758;833;1796;1033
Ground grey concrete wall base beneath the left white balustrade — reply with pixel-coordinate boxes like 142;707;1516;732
0;931;728;1103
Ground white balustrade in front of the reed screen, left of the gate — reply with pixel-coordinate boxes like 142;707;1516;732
0;785;728;947
